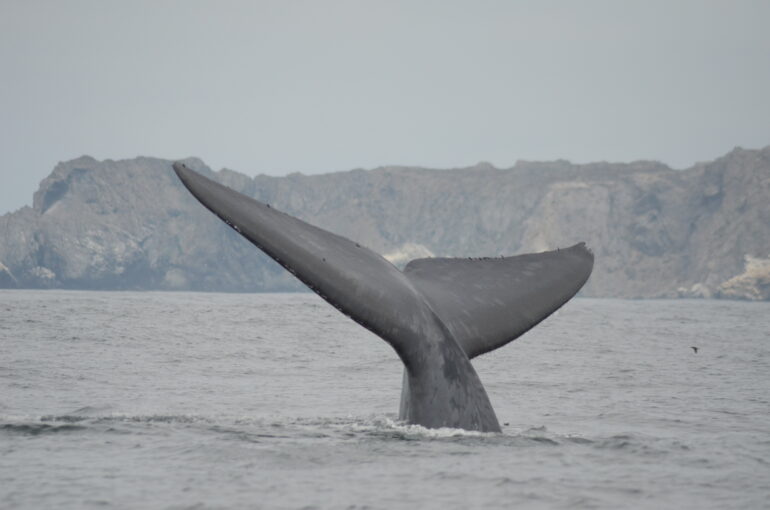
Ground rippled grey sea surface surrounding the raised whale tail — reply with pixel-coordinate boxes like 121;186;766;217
0;290;770;509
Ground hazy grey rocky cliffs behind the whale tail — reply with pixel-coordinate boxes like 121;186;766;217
0;147;770;300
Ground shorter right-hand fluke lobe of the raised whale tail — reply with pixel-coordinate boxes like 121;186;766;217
404;243;593;359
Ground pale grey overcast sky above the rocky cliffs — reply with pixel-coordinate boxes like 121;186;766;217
0;0;770;214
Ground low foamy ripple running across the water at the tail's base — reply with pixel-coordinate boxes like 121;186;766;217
0;407;689;455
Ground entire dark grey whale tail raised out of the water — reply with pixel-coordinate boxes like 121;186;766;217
173;163;593;432
